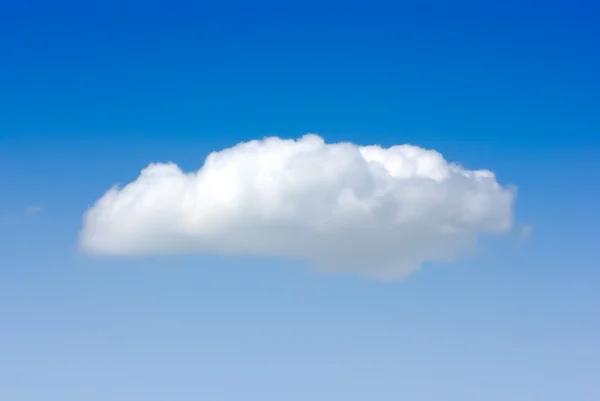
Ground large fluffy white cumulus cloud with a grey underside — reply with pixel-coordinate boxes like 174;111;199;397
80;135;514;278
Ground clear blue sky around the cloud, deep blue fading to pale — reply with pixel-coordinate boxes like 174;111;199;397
0;0;600;401
